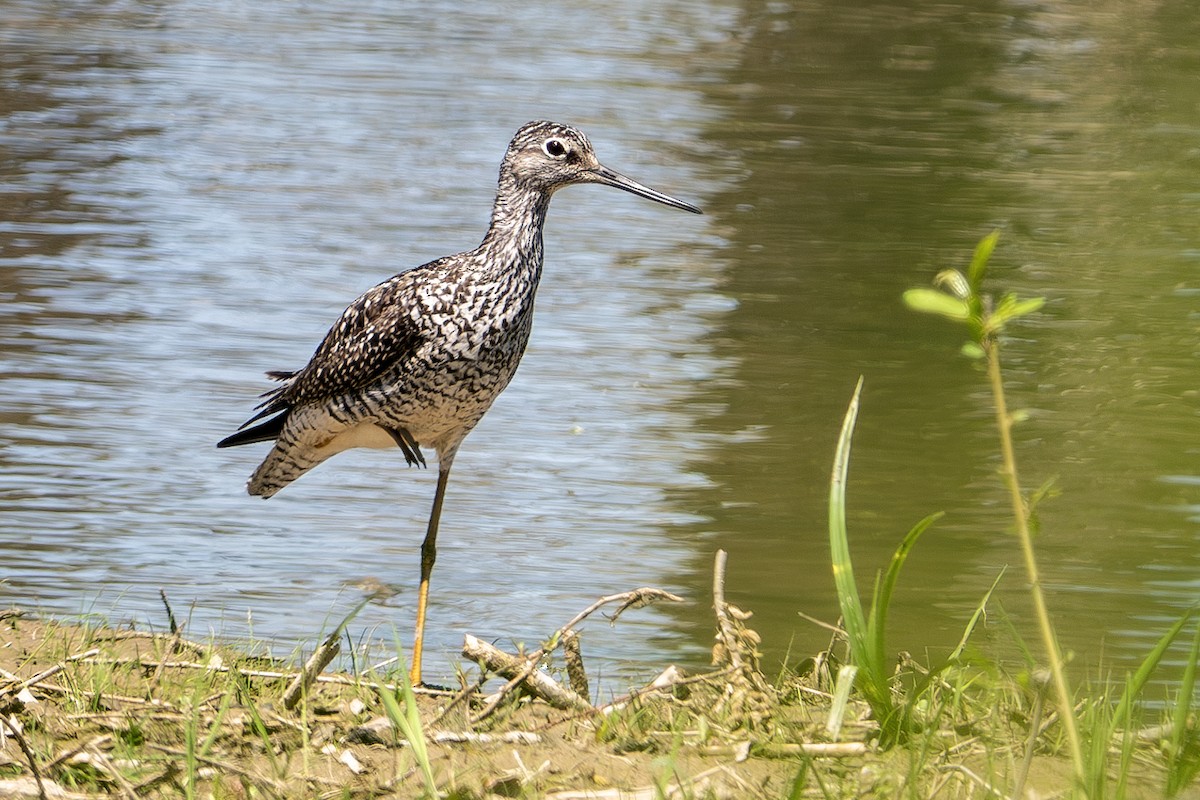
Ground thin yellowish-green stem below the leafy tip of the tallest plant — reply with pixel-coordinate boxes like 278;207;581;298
983;336;1085;786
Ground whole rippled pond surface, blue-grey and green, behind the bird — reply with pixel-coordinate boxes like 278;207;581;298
0;0;1200;679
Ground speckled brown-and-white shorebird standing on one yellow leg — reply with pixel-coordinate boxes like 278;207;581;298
217;120;701;685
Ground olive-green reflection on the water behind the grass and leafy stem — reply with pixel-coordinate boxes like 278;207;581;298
677;2;1200;681
